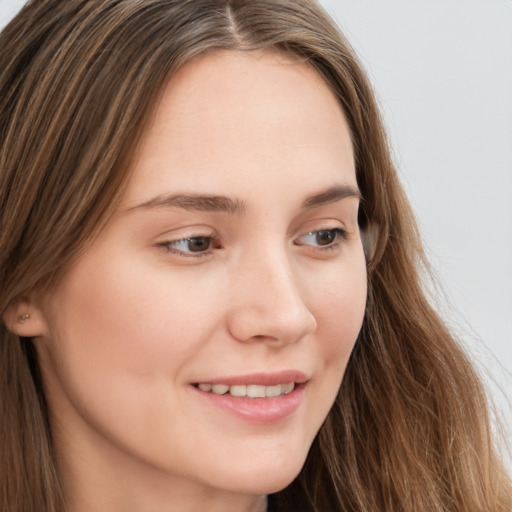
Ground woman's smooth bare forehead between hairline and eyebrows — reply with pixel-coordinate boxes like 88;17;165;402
123;51;356;206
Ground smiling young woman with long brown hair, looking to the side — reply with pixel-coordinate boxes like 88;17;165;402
0;0;511;512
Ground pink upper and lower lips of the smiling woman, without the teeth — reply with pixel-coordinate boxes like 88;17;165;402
191;371;308;425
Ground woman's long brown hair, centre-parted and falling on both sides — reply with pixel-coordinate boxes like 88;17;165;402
0;0;512;512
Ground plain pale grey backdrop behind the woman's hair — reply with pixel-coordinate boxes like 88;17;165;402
0;0;512;469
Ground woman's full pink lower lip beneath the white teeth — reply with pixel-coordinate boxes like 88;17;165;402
193;384;306;425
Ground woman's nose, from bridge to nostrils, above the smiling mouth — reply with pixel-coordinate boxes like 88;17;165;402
228;246;317;345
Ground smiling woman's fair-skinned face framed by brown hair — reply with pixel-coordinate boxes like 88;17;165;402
35;52;366;506
